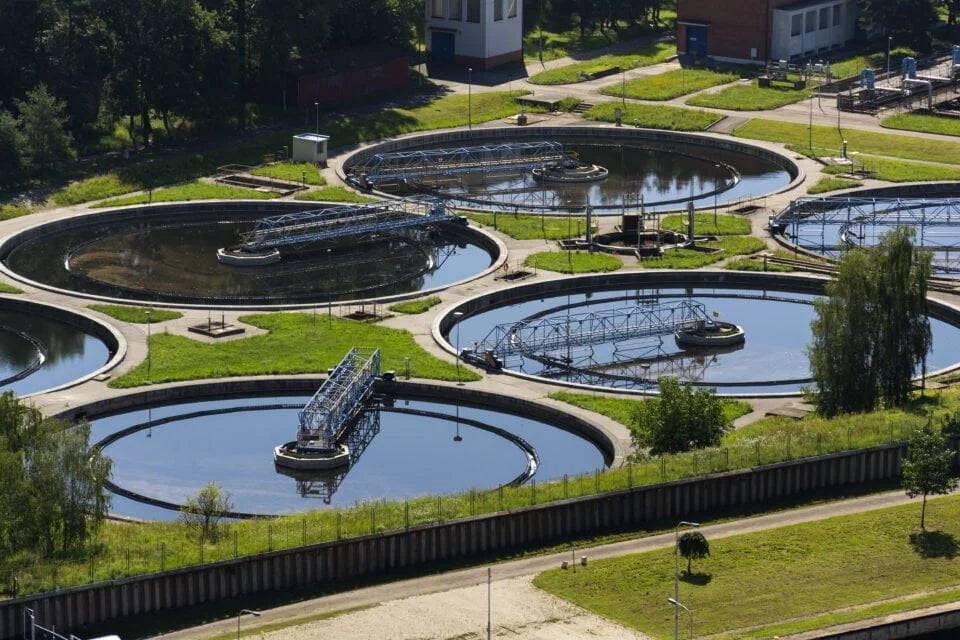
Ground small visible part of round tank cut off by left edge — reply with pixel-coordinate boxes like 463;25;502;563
0;298;124;396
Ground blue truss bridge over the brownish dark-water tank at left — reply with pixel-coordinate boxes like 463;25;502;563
239;197;460;253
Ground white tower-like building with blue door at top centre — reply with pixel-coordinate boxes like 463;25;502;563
426;0;523;69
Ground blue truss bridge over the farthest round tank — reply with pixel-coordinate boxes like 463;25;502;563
351;141;569;185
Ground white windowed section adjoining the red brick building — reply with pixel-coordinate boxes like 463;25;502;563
771;0;857;60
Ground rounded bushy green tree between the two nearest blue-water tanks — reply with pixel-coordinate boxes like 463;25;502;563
633;378;730;455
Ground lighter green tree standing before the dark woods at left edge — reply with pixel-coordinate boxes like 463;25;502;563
17;84;73;171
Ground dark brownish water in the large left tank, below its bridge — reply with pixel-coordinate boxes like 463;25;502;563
6;216;492;304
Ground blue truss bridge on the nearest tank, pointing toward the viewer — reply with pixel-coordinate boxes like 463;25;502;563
297;347;380;453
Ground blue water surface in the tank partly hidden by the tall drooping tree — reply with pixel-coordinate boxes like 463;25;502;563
453;287;960;393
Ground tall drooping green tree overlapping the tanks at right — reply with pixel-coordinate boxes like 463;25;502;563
808;227;932;416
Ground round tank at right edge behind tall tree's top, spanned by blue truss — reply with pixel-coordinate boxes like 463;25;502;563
770;197;960;272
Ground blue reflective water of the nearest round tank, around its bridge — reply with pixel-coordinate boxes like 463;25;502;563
85;381;612;519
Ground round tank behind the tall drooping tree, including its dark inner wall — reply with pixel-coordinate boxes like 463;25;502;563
434;272;960;396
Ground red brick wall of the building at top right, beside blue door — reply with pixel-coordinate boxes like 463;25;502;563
677;0;796;61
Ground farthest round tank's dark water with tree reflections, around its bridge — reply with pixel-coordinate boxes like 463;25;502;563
342;127;800;215
